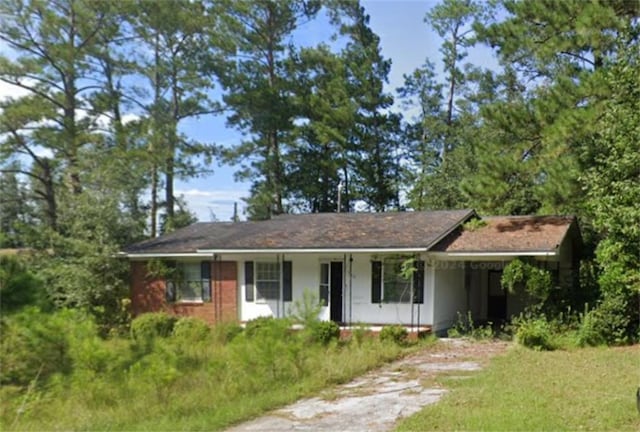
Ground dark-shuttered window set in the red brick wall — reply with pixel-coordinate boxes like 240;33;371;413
166;261;211;302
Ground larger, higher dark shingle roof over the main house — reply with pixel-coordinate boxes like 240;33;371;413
124;210;475;254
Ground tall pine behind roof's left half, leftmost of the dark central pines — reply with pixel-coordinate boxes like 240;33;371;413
221;0;320;219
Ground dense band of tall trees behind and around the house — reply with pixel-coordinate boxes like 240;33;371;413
0;0;640;343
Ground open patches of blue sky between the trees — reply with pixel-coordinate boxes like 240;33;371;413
176;0;496;221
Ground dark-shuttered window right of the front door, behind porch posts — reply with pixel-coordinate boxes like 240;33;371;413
371;259;424;303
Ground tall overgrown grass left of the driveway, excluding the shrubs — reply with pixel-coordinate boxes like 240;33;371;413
0;310;424;431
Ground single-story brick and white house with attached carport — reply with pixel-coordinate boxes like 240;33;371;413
122;210;580;332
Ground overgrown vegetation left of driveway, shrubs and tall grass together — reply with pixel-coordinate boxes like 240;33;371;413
0;308;410;430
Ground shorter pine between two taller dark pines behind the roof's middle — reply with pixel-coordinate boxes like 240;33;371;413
287;45;355;212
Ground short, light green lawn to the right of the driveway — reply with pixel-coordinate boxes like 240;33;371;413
398;345;640;431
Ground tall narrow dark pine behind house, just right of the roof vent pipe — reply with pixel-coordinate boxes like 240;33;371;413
341;2;401;211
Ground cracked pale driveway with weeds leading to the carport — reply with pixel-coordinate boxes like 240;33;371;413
229;339;509;432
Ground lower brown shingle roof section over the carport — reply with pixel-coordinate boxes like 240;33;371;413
432;216;575;253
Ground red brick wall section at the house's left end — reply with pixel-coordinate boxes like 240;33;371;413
131;261;238;324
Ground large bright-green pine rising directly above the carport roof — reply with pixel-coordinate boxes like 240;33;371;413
467;0;640;213
